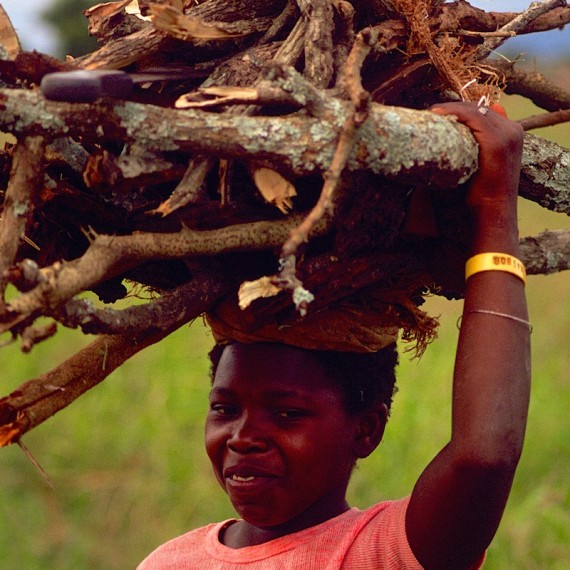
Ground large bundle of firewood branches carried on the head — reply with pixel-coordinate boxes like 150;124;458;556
0;0;570;446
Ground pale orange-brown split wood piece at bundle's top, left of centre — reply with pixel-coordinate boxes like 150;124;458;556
149;4;242;42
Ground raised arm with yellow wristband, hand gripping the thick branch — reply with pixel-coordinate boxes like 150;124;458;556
406;103;530;570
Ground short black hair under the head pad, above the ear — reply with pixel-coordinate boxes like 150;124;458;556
209;342;398;415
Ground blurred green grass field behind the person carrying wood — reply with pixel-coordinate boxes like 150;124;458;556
0;92;570;570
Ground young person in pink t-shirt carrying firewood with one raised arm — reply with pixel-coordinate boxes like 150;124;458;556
139;103;530;570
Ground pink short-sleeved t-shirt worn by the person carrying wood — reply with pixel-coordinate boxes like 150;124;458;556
137;497;466;570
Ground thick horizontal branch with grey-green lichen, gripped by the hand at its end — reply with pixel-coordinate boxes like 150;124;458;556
0;85;477;183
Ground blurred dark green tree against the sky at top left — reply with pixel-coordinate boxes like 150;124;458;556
41;0;97;57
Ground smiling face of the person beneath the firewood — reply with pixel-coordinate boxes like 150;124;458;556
206;344;359;528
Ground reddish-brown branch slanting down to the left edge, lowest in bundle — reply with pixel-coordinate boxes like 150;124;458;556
0;273;228;447
